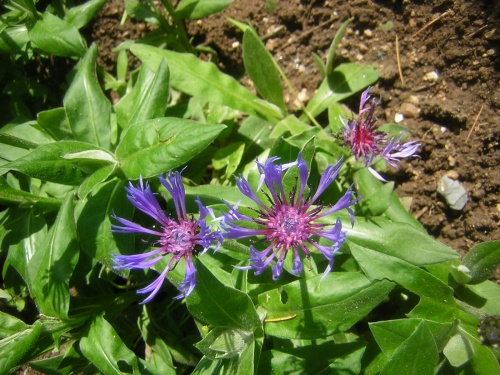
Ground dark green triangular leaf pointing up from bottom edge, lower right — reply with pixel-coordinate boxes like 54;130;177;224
380;321;439;375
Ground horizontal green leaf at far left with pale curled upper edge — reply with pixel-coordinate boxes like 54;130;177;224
3;141;112;185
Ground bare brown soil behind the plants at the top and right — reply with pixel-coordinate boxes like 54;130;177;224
91;0;500;254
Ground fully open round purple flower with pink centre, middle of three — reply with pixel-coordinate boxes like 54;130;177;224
221;153;358;280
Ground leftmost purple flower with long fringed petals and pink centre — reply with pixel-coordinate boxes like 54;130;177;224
112;171;222;304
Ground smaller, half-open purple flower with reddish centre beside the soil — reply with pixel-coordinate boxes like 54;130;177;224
344;87;420;181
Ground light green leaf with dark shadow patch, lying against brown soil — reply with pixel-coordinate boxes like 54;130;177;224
300;63;378;121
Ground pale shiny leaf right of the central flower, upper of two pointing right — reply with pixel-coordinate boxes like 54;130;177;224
342;212;459;266
